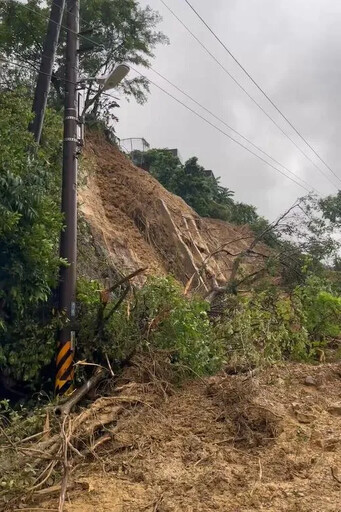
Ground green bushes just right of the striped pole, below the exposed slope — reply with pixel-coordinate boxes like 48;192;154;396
78;277;223;376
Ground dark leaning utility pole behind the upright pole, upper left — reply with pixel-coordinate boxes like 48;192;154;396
29;0;65;144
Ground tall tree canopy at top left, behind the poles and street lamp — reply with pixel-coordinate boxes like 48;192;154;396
0;0;167;121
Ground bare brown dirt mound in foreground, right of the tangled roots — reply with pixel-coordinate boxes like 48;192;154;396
33;364;341;512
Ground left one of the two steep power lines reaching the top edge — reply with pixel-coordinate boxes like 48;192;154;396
160;0;338;190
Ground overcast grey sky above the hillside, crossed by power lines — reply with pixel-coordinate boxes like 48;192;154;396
117;0;341;219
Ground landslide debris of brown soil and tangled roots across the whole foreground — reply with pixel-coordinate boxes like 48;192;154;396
2;359;341;512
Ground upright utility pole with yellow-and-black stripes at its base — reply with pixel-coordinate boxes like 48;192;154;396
55;0;79;394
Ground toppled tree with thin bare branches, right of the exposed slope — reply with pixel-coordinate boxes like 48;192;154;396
186;195;340;304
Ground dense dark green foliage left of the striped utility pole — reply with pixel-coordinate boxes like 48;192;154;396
0;91;62;381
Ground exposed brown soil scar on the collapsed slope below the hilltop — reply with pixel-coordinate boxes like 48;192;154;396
79;134;267;290
